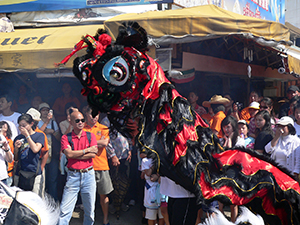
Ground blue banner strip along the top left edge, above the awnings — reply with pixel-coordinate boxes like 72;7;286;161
0;0;173;13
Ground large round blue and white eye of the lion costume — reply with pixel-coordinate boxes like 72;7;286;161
102;56;130;86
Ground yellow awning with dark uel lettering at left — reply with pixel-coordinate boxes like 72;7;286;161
0;25;103;70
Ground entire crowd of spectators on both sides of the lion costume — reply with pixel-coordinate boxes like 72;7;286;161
0;83;300;225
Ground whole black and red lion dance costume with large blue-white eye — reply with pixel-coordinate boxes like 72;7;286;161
56;22;300;225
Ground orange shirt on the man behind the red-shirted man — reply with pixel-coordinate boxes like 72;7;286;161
83;122;109;170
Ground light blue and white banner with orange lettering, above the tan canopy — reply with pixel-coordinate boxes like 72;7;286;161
174;0;285;24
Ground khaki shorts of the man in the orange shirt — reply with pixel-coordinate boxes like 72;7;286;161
95;170;114;195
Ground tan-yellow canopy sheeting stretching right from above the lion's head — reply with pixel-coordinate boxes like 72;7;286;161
104;5;290;44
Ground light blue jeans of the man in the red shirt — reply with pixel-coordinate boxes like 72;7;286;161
58;169;96;225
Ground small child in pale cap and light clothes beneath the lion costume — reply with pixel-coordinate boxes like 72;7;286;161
140;153;165;225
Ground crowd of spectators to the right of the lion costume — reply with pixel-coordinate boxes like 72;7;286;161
188;85;300;222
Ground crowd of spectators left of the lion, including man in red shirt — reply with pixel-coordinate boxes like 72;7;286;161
0;83;138;224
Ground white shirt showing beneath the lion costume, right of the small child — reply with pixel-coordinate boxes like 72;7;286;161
160;177;195;198
